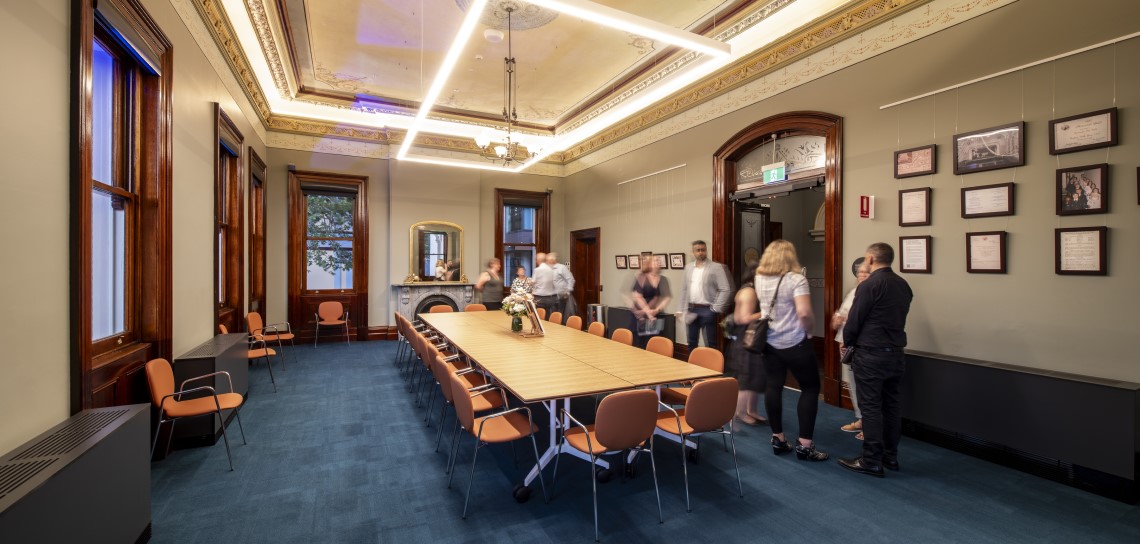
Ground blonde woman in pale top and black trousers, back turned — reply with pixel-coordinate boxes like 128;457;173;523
756;239;828;461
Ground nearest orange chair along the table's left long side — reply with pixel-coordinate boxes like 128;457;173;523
447;374;549;519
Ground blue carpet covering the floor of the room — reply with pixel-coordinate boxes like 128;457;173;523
152;342;1140;544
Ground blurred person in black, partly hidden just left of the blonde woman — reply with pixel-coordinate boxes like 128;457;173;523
727;273;768;425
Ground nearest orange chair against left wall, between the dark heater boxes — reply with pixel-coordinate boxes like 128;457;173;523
146;359;250;470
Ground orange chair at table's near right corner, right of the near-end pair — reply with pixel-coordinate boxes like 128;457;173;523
657;377;744;512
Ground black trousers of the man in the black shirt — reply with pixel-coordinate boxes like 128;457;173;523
852;348;906;466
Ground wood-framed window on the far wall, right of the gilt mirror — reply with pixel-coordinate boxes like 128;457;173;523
495;188;551;285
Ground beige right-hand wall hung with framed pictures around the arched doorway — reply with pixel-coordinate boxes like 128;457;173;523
567;0;1140;381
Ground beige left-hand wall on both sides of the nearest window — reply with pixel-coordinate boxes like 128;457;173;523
0;0;266;452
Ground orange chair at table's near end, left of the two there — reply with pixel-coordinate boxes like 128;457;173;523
551;389;661;542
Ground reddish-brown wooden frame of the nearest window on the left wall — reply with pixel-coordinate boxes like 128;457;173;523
68;0;173;413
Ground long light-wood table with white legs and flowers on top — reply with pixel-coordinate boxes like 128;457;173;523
420;311;720;484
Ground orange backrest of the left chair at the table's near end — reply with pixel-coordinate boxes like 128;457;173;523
594;389;661;449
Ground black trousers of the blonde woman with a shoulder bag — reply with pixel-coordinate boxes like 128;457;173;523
764;338;825;440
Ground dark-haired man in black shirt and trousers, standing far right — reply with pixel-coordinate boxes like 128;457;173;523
839;242;914;478
